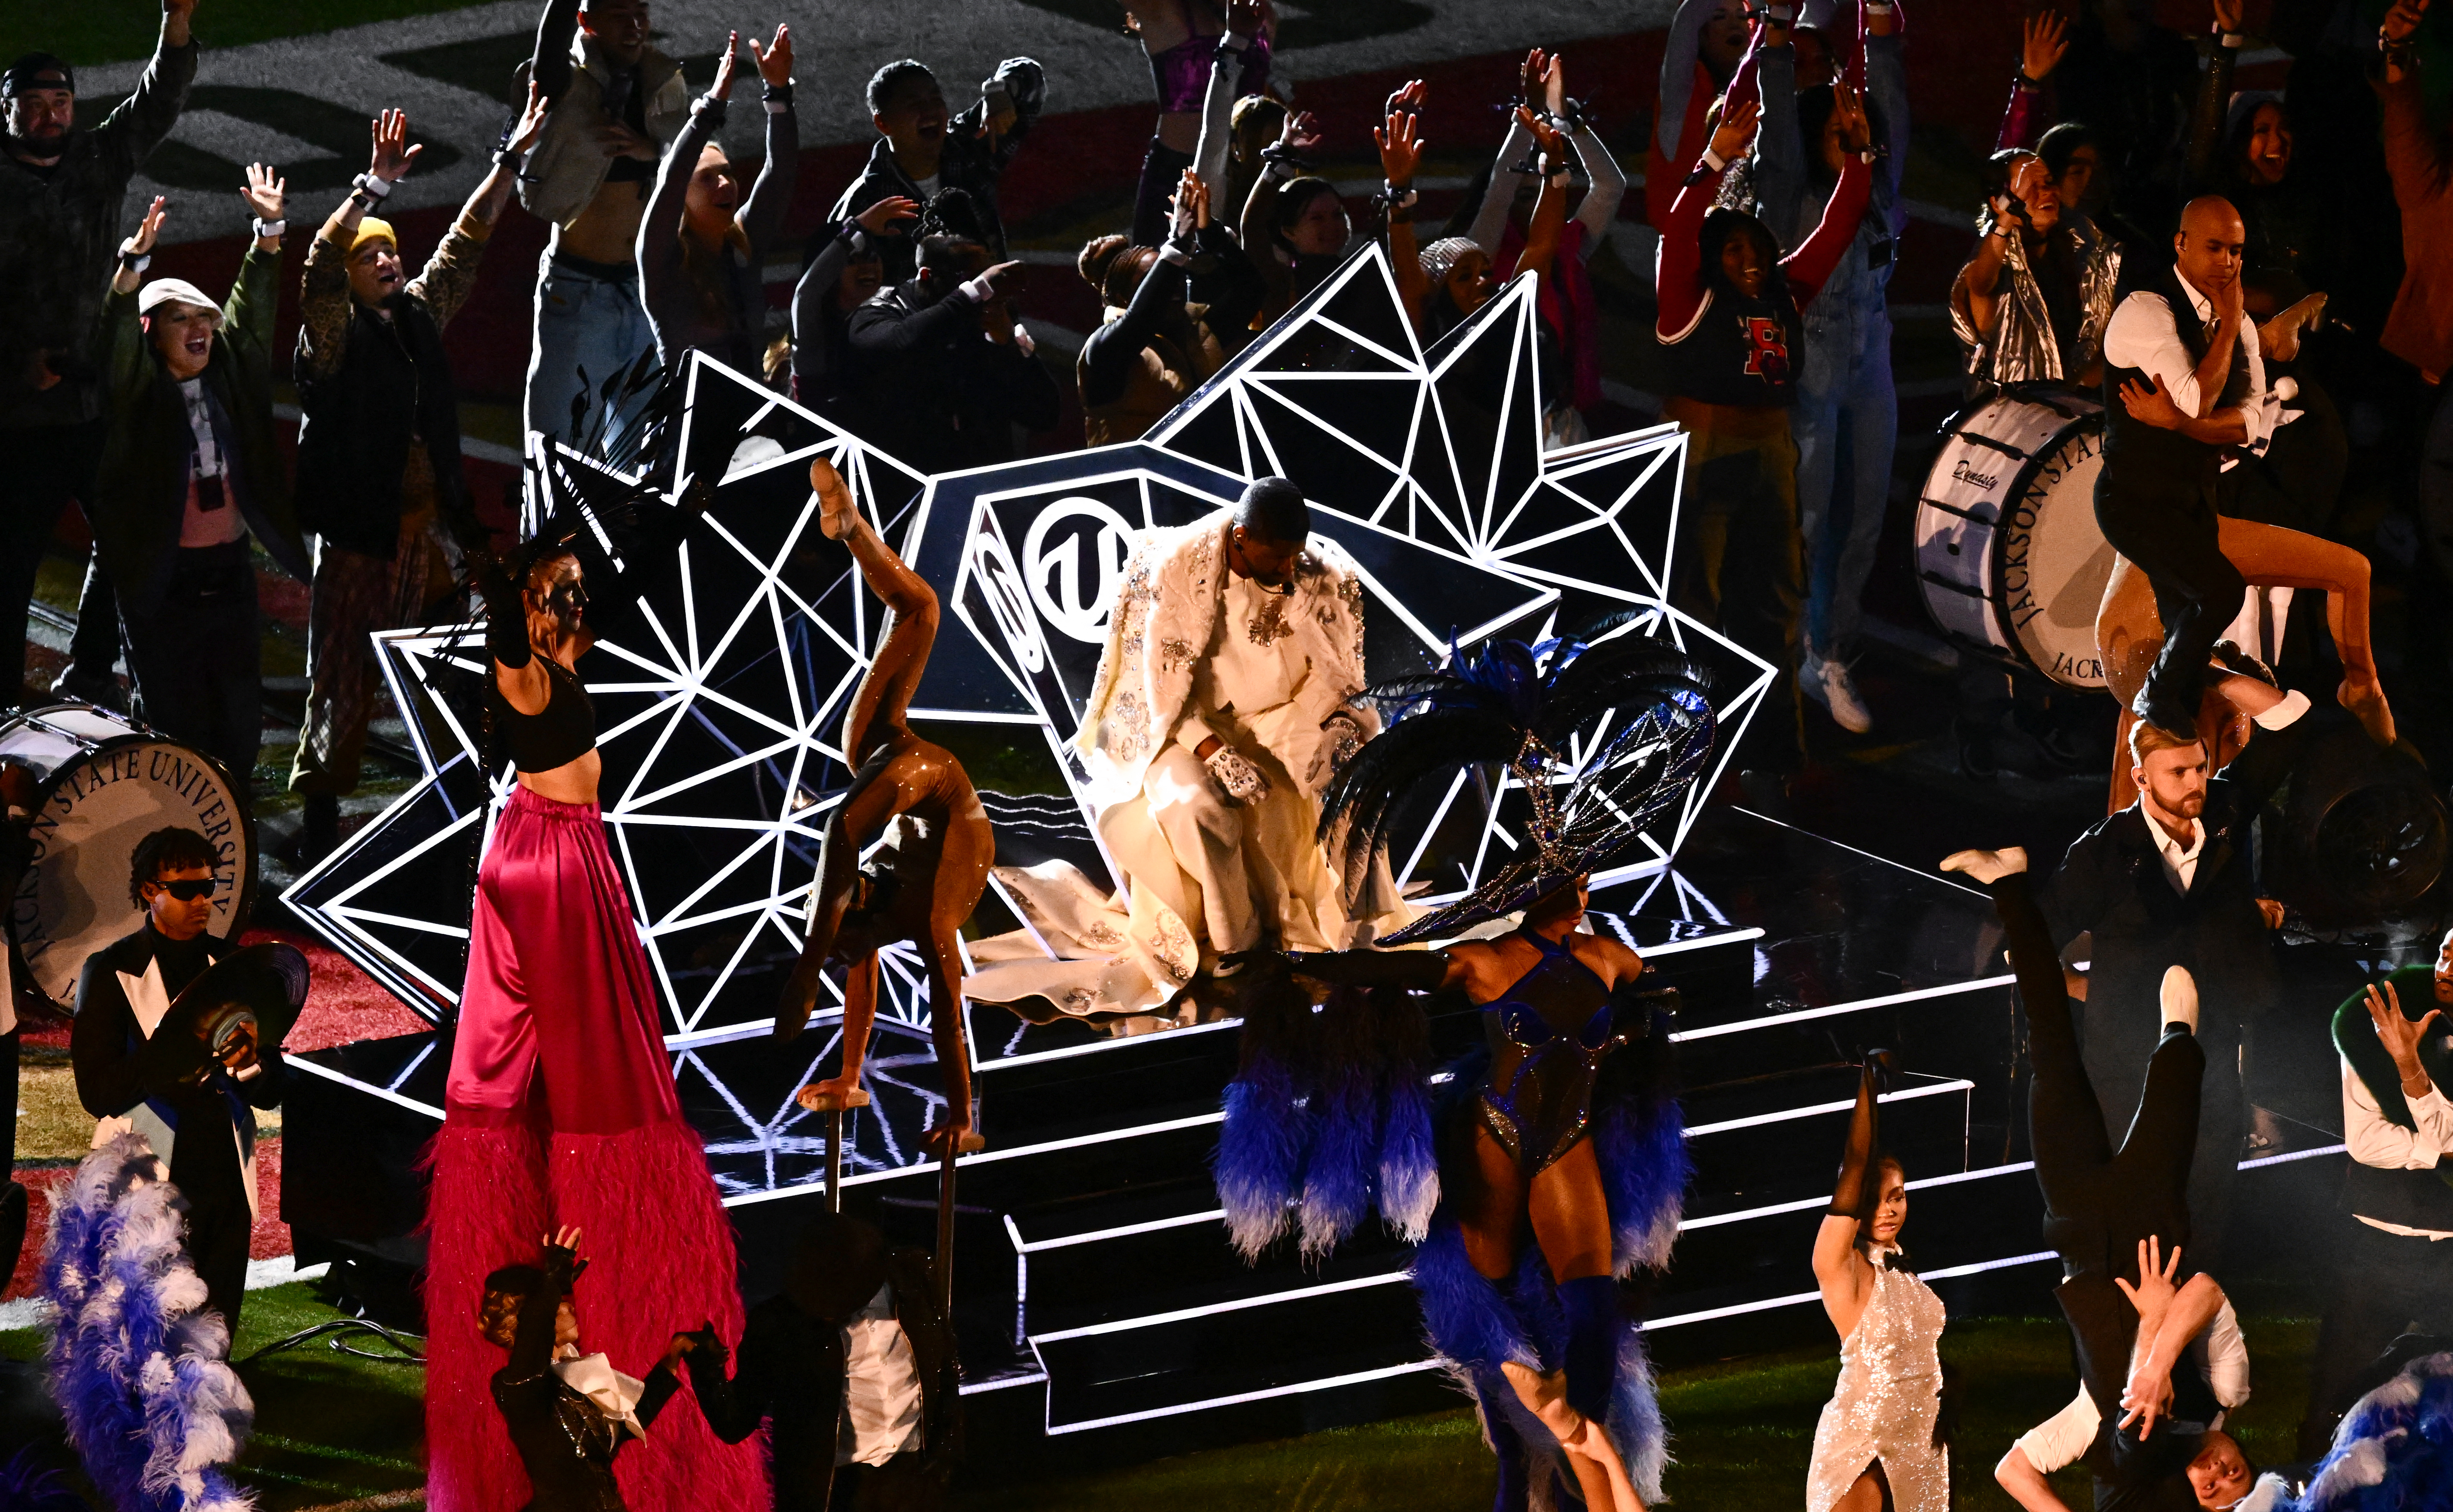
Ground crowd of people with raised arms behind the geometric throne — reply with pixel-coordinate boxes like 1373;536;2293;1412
0;0;2453;818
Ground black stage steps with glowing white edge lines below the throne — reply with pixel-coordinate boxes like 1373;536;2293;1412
285;806;2413;1448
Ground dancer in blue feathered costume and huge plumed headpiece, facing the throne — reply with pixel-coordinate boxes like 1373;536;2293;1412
1217;637;1712;1512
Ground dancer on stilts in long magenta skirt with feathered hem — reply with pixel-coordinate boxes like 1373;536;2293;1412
424;520;768;1512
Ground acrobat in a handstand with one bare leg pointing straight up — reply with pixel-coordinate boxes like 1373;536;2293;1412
775;458;996;1154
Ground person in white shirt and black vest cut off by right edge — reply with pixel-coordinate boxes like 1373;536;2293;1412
2301;934;2453;1458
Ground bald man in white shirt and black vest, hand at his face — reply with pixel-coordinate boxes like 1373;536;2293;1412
2095;196;2269;737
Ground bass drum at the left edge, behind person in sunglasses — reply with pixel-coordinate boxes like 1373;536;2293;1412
0;703;255;1012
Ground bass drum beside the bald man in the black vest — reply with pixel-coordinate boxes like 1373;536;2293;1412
1916;392;2115;688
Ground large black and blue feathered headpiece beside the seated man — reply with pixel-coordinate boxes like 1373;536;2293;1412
1320;617;1712;946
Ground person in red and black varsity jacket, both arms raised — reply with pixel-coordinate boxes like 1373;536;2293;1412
1656;76;1874;784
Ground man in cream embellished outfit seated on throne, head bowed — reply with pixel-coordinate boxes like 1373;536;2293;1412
1079;478;1398;995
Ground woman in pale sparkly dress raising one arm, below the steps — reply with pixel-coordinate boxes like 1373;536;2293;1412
1805;1054;1950;1512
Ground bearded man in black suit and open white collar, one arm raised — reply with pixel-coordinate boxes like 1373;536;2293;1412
2043;672;2320;1269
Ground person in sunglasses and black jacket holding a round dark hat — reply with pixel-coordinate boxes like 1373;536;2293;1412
68;816;289;1335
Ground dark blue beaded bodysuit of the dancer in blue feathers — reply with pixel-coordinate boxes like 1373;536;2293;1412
1481;931;1621;1176
